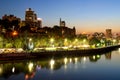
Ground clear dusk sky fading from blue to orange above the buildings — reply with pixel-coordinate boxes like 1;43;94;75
0;0;120;34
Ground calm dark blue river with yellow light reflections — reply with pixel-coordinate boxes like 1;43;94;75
0;49;120;80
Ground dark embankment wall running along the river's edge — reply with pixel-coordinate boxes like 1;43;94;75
0;45;120;60
